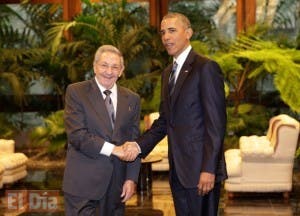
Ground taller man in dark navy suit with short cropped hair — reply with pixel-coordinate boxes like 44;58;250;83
123;13;227;216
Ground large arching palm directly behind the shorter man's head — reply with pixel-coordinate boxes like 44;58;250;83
47;0;164;85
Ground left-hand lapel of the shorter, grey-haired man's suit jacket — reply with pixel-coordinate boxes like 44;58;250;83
86;79;113;132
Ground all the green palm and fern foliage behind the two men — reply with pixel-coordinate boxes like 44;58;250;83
0;0;300;155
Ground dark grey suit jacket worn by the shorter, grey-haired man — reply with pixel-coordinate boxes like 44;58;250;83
63;79;140;200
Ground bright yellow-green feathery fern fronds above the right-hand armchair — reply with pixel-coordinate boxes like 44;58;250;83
215;36;300;113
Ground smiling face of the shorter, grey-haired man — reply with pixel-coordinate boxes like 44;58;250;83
94;52;124;89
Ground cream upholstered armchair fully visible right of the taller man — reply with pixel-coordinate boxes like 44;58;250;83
224;114;299;198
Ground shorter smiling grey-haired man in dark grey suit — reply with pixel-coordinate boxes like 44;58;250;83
63;45;140;216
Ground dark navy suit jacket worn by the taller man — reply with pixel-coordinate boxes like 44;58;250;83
137;50;227;188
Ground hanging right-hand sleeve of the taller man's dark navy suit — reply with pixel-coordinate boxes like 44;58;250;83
200;61;226;174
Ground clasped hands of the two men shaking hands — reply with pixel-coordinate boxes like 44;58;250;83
112;142;141;161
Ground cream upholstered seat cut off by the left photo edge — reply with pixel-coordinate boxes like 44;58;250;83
0;139;28;188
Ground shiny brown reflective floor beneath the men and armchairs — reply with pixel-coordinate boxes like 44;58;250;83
0;166;300;216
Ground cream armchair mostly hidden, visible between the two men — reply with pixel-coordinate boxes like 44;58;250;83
144;112;169;171
